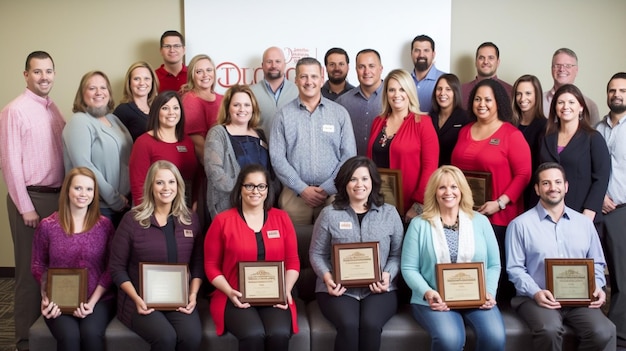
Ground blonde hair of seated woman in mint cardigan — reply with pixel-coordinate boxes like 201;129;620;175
422;165;474;223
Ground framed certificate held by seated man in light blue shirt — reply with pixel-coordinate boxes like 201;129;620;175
545;258;596;306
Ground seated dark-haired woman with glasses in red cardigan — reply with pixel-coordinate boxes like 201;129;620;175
204;164;300;351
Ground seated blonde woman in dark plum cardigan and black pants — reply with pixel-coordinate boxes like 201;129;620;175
109;161;204;350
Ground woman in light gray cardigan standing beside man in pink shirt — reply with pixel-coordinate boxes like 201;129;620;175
63;71;133;227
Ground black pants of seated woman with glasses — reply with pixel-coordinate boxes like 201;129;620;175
224;301;292;351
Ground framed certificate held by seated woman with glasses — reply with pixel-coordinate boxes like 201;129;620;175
239;261;287;306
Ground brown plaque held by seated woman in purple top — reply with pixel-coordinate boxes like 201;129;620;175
46;268;87;314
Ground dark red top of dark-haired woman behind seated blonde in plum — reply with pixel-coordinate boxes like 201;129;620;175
128;133;198;205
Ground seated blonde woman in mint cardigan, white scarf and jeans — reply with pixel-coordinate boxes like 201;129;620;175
401;166;506;350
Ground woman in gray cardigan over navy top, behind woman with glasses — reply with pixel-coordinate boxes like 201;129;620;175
204;85;271;217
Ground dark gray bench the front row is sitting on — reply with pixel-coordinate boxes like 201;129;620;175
30;226;577;351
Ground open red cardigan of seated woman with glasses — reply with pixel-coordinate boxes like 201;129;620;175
204;208;300;335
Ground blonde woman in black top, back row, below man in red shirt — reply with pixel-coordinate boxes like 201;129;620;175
113;61;159;141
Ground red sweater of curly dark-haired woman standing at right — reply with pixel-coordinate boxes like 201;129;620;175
452;122;532;226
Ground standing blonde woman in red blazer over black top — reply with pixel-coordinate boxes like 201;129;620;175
367;69;439;221
